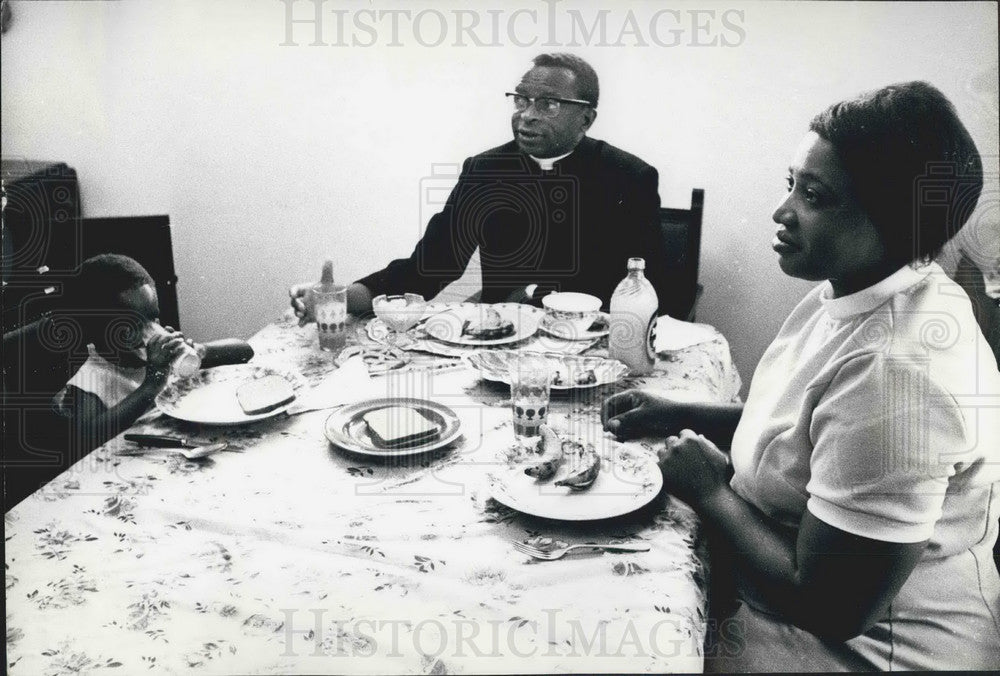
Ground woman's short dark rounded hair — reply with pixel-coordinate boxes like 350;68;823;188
809;82;983;262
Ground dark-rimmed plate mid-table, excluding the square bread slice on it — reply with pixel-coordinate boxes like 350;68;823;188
323;397;461;458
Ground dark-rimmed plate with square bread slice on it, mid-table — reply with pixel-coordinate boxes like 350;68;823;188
324;397;461;457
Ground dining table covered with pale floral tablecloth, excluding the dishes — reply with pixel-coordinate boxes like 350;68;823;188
4;304;741;675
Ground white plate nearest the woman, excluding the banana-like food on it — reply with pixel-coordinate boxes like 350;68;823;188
487;435;663;521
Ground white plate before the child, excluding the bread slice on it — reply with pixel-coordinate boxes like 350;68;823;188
156;364;307;425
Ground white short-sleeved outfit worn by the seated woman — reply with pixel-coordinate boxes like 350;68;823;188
731;264;1000;668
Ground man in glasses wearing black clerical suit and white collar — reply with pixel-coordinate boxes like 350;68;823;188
291;54;686;318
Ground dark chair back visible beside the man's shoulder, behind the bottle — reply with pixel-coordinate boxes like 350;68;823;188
660;188;705;321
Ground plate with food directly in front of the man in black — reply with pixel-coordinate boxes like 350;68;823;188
423;303;544;346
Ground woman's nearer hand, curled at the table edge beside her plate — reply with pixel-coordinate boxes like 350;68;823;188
657;430;729;509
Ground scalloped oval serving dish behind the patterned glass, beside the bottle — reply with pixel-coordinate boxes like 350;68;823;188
462;350;628;390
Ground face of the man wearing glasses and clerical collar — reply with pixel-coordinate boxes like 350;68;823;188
511;66;597;158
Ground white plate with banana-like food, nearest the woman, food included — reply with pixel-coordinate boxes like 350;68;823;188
487;425;663;521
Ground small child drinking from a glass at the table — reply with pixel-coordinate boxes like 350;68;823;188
54;254;253;452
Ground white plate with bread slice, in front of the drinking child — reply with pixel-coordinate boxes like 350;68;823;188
156;364;308;425
